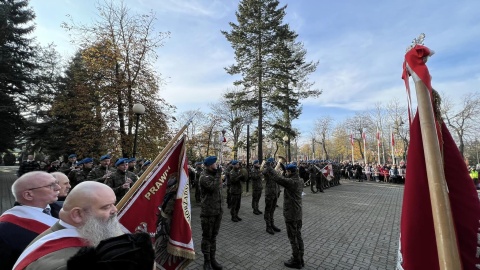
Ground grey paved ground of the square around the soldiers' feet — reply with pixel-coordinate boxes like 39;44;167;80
0;166;403;270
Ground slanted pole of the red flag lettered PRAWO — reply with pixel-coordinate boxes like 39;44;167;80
116;113;196;212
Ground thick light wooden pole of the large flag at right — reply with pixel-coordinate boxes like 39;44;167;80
410;77;462;270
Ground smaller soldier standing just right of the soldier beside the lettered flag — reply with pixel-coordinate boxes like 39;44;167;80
229;160;244;222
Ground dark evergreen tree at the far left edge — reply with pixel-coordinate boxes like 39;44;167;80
0;0;35;152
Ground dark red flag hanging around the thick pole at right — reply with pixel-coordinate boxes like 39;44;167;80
397;113;480;270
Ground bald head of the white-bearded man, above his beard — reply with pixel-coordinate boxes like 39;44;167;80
60;181;117;227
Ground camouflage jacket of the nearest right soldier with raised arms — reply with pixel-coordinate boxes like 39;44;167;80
269;169;303;222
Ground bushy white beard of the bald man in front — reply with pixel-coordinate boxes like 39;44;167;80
78;214;123;247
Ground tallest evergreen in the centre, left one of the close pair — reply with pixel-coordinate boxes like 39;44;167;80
222;0;295;158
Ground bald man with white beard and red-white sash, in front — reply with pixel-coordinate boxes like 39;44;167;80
13;181;123;270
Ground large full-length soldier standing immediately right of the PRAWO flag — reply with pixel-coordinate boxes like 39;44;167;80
200;156;223;269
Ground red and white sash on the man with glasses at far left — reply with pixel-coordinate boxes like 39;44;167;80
0;205;58;234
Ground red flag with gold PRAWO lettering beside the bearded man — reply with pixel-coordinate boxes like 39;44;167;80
118;138;195;269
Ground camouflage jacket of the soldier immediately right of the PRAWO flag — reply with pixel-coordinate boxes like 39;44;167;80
200;170;223;217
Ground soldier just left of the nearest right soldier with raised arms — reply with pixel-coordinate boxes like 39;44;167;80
262;158;281;234
